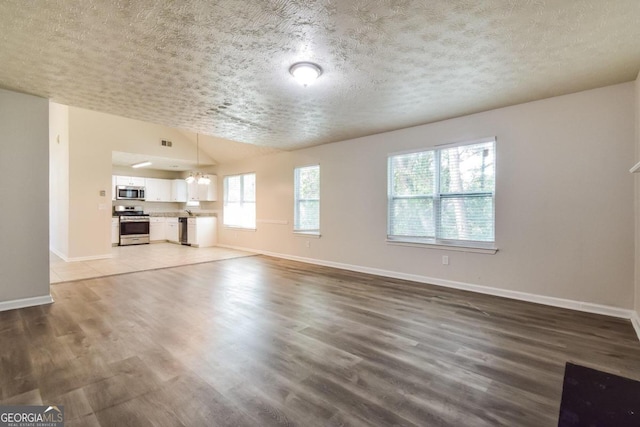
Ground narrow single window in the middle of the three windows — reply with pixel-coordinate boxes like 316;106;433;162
293;165;320;233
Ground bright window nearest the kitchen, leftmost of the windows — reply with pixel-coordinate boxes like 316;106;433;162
222;173;256;229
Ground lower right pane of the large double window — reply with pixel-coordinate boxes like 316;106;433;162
438;196;495;242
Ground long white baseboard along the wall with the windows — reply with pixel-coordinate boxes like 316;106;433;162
218;244;640;324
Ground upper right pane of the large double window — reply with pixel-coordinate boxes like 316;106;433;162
440;142;495;194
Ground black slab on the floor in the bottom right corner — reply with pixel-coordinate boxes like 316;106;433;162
558;362;640;427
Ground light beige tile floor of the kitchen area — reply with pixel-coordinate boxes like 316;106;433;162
49;243;255;283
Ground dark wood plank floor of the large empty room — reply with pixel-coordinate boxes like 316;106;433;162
0;256;640;427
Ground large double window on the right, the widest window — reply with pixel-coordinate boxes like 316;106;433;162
387;138;495;248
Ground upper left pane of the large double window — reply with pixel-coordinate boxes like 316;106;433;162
390;151;435;196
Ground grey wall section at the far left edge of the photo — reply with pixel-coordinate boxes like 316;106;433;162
0;90;50;309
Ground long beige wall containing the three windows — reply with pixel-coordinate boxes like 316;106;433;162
218;83;634;309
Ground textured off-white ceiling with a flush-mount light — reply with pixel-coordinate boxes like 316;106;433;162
0;0;640;154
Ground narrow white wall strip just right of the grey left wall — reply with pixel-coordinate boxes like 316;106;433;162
49;102;69;256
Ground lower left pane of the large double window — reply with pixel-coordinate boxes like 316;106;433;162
389;198;435;237
